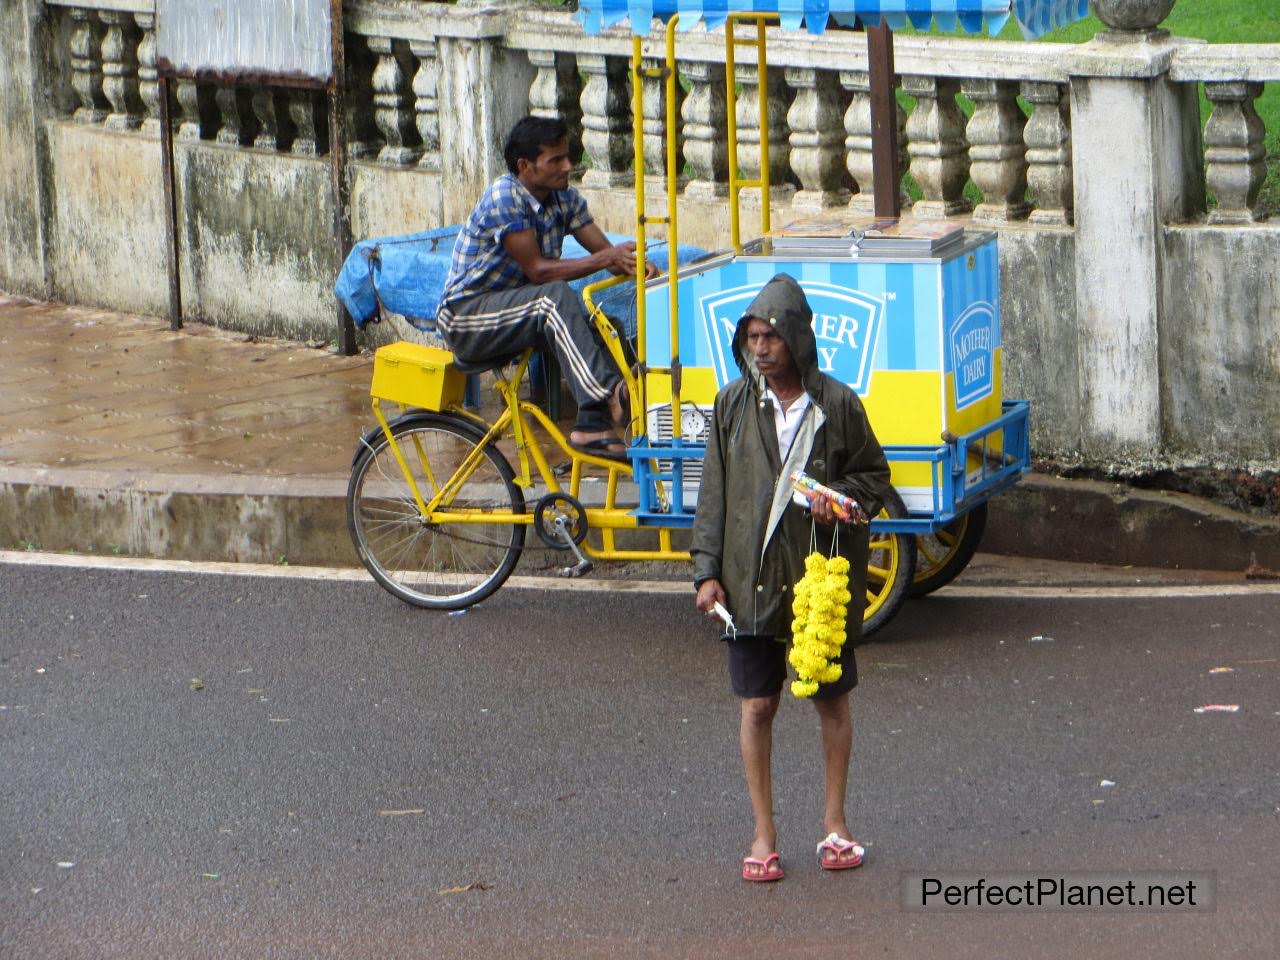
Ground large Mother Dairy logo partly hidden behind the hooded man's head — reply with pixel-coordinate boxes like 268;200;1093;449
699;280;884;396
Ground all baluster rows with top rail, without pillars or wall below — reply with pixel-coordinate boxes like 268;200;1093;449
46;0;1280;225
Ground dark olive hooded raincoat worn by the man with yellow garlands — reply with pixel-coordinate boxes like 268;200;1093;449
691;274;891;655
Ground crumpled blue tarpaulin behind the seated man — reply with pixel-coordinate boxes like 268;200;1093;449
334;227;707;337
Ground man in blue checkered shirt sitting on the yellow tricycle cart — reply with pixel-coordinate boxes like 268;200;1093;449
436;116;657;458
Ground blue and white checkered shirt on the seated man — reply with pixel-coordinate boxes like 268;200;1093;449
440;173;591;307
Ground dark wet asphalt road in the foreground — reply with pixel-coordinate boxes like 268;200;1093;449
0;566;1280;960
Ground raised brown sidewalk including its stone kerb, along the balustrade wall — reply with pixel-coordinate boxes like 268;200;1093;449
0;293;1280;579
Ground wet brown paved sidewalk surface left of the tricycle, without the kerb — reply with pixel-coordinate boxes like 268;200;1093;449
0;296;372;477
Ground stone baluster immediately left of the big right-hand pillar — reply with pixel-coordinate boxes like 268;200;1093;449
1023;82;1074;227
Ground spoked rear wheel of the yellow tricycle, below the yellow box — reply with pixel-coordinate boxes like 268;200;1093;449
347;413;525;611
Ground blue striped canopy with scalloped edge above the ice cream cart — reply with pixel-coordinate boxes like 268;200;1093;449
577;0;1089;37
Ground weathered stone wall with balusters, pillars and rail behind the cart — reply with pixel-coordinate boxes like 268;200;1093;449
0;0;1280;468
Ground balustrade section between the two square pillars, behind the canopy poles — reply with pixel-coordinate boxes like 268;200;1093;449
506;12;1071;224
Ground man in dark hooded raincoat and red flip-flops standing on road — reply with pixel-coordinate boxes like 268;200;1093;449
692;274;891;881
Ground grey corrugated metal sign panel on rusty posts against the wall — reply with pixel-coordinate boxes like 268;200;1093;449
156;0;334;86
